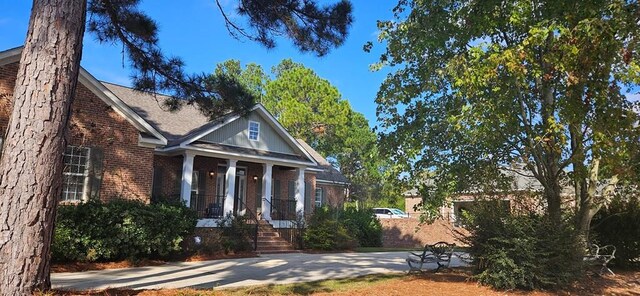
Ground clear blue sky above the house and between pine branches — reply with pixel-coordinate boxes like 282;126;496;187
0;0;395;126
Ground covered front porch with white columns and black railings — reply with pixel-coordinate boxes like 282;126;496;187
153;153;315;227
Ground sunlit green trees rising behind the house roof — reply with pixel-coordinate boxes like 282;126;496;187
214;59;401;204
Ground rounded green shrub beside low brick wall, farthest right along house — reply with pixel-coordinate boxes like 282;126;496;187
339;207;382;247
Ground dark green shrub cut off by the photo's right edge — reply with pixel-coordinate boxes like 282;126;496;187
591;196;640;267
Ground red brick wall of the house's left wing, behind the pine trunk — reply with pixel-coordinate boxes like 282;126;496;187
0;63;153;201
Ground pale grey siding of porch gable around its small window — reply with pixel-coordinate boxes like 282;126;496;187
200;111;296;154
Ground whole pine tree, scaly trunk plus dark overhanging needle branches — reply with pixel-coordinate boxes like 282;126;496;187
0;0;353;295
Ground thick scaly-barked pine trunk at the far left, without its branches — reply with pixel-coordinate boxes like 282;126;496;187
0;0;86;295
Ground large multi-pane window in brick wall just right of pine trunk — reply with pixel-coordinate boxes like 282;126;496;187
60;146;90;202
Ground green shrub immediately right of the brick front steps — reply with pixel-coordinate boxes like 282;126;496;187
303;207;357;251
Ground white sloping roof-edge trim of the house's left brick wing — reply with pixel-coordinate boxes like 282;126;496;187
0;46;167;145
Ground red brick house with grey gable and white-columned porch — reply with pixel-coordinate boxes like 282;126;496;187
0;48;348;252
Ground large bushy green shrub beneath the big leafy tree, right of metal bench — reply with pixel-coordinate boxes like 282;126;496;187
463;202;582;290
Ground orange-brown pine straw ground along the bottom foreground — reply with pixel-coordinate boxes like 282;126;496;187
47;271;640;296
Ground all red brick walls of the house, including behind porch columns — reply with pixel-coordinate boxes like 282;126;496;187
0;63;345;211
